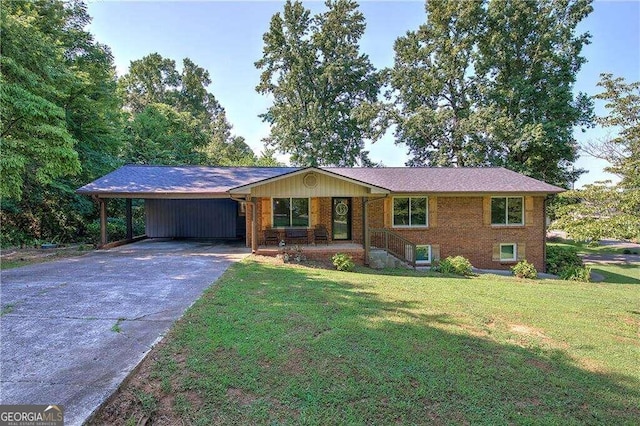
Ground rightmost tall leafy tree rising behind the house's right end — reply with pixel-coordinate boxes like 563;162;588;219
477;0;592;186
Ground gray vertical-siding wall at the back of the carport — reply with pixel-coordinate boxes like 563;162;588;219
144;199;239;238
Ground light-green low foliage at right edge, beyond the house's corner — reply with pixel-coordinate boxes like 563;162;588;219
552;181;640;241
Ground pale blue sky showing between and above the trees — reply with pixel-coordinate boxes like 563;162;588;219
88;1;640;187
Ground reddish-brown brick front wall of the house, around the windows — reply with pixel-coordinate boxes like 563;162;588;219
247;196;545;272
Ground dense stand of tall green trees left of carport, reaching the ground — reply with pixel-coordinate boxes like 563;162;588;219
0;0;121;244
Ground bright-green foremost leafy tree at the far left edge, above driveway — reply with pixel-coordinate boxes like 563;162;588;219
0;0;80;200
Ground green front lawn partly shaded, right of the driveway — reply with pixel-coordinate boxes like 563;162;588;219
93;258;640;425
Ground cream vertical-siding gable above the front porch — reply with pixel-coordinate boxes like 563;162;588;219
251;172;369;198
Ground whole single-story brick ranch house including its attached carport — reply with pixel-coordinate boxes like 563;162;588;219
78;165;563;271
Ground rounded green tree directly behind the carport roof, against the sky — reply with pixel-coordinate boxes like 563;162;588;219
118;53;255;165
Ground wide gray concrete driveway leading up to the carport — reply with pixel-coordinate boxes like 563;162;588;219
0;240;249;425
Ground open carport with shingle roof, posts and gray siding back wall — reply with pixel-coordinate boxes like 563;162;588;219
77;165;291;247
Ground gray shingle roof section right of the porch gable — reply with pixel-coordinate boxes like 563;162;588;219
326;167;564;194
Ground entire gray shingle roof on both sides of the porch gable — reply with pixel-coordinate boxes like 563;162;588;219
78;165;564;198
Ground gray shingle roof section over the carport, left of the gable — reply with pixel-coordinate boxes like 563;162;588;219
77;165;298;198
